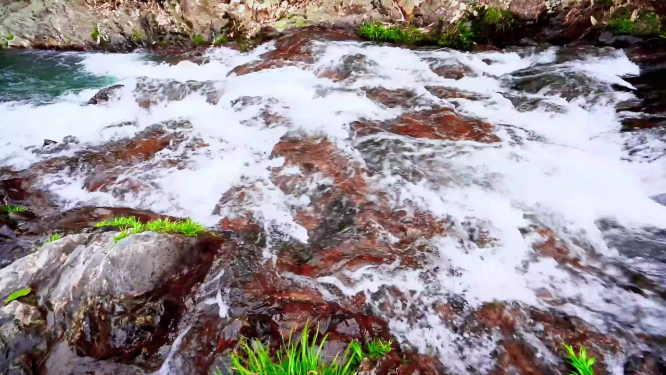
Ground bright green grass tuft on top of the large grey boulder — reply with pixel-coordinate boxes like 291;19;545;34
95;216;206;242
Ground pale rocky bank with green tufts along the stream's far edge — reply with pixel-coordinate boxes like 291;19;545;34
0;0;666;51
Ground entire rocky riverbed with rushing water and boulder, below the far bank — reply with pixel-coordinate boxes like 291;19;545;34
0;28;666;374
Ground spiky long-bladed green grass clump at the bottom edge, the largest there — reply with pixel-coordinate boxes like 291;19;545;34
226;324;363;375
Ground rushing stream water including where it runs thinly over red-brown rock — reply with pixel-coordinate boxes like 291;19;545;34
0;33;666;374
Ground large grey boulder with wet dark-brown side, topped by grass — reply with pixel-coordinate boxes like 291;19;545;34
0;232;223;373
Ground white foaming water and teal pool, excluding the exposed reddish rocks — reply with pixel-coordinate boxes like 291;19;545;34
0;42;666;373
